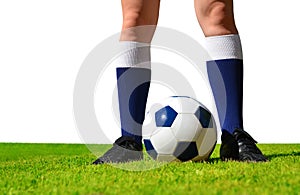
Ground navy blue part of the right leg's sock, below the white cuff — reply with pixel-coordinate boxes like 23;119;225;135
207;59;243;134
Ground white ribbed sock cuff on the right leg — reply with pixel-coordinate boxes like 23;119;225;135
205;34;243;60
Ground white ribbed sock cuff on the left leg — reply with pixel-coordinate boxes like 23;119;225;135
116;41;151;69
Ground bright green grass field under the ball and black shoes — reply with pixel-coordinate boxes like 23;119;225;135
0;143;300;194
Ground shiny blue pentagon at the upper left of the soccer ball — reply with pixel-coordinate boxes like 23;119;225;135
155;106;177;127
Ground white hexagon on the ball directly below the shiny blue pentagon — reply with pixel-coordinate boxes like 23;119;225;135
150;127;177;154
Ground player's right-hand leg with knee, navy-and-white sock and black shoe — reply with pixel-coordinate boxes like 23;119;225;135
194;0;266;161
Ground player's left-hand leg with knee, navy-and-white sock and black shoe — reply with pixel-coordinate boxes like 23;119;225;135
94;0;160;164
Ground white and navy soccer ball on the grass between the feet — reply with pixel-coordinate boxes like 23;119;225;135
143;96;217;162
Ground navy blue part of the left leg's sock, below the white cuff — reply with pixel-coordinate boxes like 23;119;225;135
116;67;151;143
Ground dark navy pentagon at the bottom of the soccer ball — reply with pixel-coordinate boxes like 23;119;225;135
174;142;198;161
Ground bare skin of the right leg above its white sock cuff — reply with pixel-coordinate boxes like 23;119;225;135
195;0;237;36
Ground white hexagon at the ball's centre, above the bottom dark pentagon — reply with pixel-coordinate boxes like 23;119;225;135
171;113;202;141
